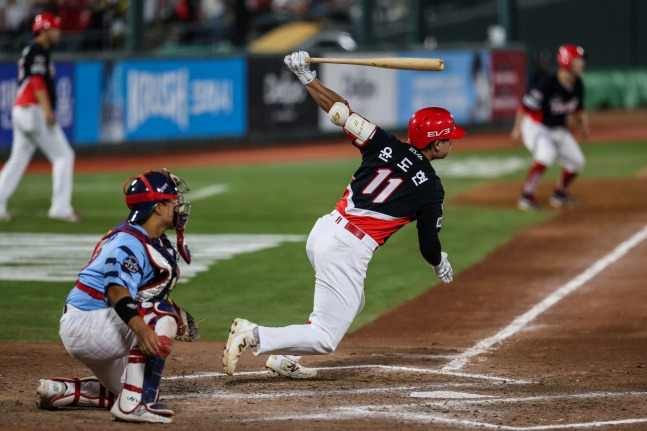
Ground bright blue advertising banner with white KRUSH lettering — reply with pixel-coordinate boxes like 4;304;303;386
121;59;247;139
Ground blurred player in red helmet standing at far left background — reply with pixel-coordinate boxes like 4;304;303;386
0;13;81;222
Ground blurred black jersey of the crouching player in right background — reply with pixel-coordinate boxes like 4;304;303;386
521;74;584;127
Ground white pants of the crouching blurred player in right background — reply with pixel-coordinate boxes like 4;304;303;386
521;116;585;173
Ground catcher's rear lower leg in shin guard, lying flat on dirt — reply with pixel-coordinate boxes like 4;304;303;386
36;377;116;410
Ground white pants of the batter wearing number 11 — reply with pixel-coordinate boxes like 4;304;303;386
254;211;378;355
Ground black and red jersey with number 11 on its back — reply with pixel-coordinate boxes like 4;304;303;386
336;128;445;253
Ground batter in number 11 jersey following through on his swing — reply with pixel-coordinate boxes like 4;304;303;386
223;51;465;378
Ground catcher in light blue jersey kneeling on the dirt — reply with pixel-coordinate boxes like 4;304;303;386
37;169;199;423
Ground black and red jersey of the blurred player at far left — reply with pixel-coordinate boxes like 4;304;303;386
15;42;56;109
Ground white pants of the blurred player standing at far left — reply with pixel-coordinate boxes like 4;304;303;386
0;105;74;217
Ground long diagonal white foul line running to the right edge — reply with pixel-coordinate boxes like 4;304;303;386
442;225;647;371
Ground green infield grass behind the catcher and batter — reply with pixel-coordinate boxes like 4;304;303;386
0;142;647;342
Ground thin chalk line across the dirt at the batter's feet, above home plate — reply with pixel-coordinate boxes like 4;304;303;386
162;365;533;385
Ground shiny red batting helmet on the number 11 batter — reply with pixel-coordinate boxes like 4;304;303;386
407;108;465;150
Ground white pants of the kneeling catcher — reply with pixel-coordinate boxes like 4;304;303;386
59;305;137;394
